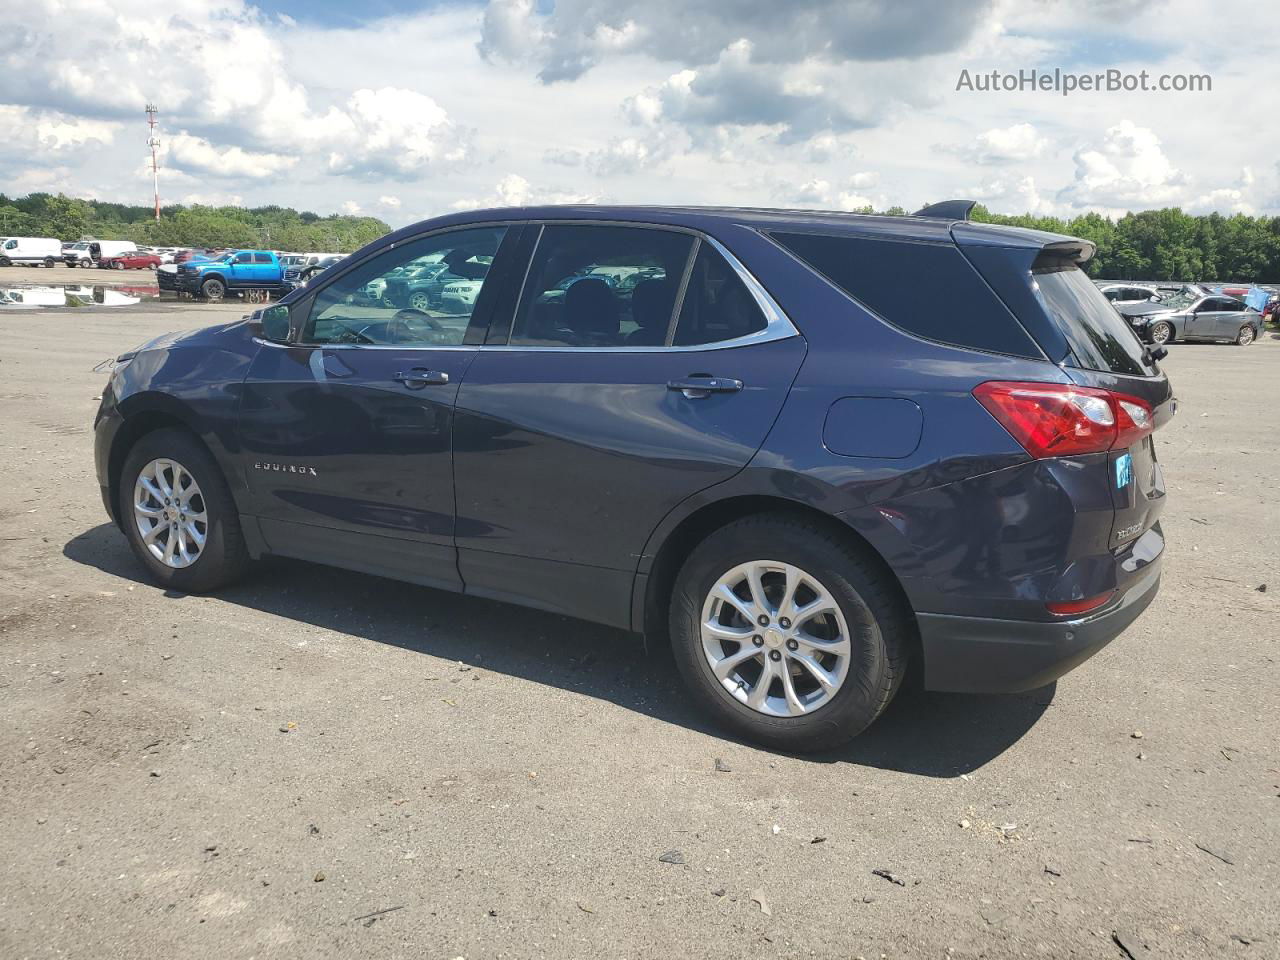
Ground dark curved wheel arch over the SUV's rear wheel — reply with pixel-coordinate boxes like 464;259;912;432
631;494;915;640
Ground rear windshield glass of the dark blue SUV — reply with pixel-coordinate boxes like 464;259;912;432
1032;264;1155;376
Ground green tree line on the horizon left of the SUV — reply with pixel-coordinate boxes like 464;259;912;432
0;193;392;253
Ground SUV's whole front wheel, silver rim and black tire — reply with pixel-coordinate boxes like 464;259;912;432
118;429;248;593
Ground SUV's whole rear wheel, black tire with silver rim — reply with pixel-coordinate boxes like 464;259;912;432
669;513;914;753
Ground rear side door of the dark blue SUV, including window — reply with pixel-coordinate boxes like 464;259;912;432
454;224;805;626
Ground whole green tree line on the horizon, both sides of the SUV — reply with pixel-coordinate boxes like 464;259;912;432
0;193;1280;283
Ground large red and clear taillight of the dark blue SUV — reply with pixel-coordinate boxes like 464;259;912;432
973;380;1155;458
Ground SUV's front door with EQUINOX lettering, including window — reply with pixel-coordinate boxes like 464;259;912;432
239;225;517;589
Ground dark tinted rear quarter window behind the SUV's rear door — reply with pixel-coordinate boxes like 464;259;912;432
771;233;1039;358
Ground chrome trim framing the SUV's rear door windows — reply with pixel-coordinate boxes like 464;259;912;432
494;219;800;353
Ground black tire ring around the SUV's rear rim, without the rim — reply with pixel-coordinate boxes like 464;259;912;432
669;518;905;753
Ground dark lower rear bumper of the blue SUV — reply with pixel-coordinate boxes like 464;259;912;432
916;559;1160;694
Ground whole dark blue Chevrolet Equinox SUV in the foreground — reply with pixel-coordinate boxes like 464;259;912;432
96;202;1174;750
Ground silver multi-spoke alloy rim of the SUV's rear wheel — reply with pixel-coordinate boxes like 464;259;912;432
700;559;860;717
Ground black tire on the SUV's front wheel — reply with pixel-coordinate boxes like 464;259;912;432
116;428;250;593
